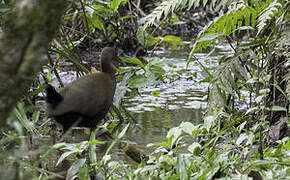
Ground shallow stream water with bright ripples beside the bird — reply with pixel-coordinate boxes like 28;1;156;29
43;46;233;162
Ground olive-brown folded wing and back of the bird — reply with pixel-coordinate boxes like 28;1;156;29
50;72;115;116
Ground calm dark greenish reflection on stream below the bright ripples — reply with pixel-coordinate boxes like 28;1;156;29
126;107;202;146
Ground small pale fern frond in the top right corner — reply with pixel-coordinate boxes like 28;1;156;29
257;0;282;34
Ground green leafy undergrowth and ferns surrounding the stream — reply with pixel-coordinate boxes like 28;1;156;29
0;0;290;179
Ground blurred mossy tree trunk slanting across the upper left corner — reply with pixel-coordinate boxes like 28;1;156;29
0;0;66;127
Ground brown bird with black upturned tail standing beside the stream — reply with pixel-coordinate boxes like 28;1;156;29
45;47;118;132
